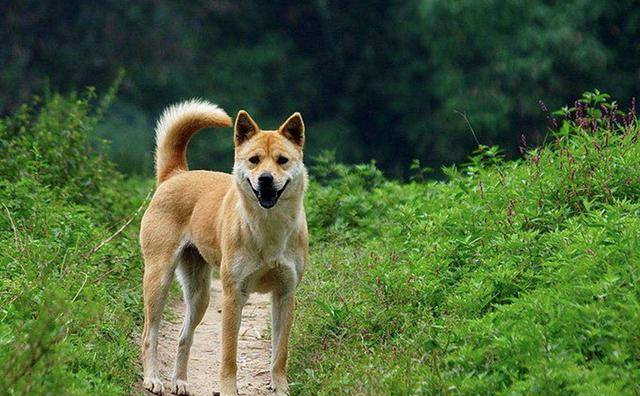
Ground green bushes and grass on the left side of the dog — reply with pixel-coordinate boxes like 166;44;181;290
0;91;148;396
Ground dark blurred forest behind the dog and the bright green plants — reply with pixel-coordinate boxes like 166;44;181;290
0;0;640;176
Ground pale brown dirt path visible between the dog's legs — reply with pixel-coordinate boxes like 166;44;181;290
140;279;272;396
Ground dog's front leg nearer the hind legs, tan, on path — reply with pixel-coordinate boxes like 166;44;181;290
220;286;247;396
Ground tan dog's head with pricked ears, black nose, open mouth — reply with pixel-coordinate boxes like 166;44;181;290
233;110;305;209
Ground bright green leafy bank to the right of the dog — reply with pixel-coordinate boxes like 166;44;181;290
291;92;640;396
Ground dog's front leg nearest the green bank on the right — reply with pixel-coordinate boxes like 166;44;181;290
271;291;295;396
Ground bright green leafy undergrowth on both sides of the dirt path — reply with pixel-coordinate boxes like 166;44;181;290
0;91;640;396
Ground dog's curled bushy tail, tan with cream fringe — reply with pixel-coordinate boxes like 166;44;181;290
156;99;232;184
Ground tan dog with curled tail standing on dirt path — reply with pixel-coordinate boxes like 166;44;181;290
140;100;308;396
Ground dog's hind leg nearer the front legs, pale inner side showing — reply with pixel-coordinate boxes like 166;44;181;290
171;247;212;395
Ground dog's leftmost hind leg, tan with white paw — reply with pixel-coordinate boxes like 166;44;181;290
142;253;176;395
